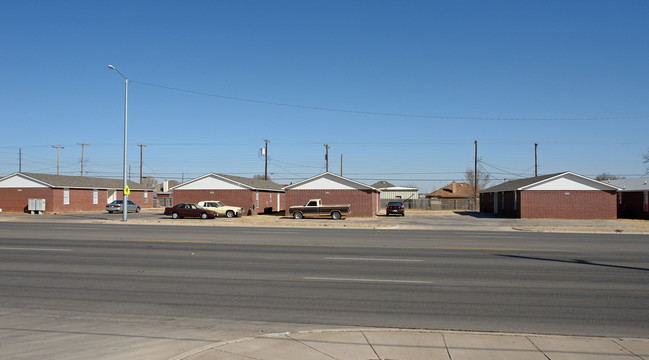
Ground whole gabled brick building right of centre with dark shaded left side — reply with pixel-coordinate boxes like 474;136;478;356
480;172;618;219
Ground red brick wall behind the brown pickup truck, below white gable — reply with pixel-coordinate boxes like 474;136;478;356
286;190;379;217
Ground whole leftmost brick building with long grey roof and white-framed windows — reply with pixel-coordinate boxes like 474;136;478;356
0;173;153;213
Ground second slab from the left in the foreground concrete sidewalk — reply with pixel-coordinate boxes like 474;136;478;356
290;331;378;360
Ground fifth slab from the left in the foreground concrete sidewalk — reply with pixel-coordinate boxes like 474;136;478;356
529;336;638;360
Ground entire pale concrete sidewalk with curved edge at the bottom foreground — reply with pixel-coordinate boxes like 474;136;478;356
173;329;649;360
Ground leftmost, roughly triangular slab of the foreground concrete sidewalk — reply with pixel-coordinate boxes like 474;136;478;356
210;335;331;360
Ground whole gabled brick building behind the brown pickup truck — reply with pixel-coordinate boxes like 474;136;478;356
284;172;381;217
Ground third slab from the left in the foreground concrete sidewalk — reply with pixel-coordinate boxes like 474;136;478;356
364;330;449;360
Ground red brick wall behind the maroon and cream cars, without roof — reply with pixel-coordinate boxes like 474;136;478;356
173;190;286;215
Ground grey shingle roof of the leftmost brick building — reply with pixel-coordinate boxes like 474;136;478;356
0;173;147;190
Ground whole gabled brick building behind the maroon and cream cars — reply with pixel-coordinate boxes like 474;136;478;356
170;173;284;215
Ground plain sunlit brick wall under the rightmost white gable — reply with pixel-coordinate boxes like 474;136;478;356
520;190;617;219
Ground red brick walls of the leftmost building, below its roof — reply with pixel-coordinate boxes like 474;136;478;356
0;188;153;213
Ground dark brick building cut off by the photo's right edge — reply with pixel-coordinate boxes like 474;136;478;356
607;178;649;220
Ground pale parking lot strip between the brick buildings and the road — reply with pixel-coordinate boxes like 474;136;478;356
0;208;649;233
